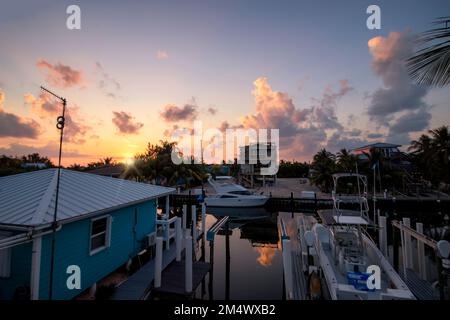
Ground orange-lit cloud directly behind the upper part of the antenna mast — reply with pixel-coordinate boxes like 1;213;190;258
24;92;91;144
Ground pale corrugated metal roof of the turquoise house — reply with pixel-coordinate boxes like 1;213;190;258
0;169;175;226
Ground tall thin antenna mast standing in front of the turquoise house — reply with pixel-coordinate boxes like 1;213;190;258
41;86;67;300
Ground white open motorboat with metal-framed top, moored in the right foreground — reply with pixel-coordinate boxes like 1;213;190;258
299;173;415;300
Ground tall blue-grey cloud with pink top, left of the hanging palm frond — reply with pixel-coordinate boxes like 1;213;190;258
367;32;431;136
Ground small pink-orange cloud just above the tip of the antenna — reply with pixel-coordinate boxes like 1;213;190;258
36;59;84;88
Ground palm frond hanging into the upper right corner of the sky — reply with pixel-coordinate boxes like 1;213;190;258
406;16;450;87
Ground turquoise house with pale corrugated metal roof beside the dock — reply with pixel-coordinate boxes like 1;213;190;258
0;169;175;299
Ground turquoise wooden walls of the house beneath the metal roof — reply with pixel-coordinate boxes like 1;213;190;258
0;200;156;300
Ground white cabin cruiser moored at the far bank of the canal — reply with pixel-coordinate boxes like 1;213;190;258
205;176;269;208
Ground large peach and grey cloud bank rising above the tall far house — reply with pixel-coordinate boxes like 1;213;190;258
241;77;353;159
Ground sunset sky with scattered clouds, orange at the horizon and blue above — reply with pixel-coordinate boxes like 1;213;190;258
0;0;450;165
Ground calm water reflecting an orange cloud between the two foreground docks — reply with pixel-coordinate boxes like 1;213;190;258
196;208;283;299
